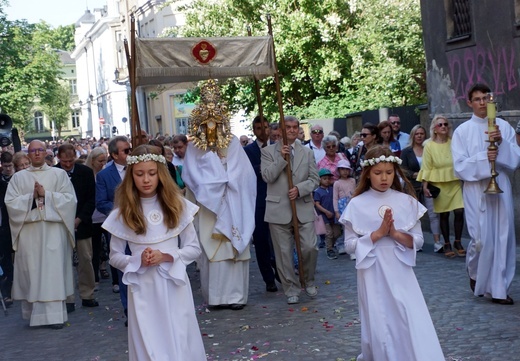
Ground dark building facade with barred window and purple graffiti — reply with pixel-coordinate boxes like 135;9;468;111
421;0;520;125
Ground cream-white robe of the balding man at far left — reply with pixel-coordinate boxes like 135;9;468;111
5;164;76;326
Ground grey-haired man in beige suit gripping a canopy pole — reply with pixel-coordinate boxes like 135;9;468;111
261;116;319;304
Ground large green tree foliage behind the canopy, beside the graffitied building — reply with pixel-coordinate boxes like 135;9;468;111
180;0;426;119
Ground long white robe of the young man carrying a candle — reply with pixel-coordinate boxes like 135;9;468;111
451;115;520;299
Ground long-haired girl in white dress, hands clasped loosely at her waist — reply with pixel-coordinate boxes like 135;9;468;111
103;145;206;361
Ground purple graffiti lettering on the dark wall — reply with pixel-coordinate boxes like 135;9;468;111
447;46;518;101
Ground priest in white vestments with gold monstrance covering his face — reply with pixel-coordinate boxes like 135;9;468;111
182;80;256;310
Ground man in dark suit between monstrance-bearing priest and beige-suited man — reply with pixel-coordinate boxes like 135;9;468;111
244;116;278;292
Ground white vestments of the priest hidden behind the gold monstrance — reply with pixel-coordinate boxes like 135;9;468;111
182;137;256;306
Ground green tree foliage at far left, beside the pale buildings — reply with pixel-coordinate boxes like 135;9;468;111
0;0;73;130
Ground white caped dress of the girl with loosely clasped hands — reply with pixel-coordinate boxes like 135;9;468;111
102;197;206;361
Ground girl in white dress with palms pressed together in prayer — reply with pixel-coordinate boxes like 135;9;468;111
340;146;444;361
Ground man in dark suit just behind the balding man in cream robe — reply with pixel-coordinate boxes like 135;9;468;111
55;143;99;312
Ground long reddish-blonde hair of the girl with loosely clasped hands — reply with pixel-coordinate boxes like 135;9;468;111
115;144;183;234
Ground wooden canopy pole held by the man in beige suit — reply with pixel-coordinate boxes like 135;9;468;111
267;14;305;288
